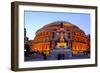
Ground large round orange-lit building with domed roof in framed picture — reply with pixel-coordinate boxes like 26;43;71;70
31;21;90;55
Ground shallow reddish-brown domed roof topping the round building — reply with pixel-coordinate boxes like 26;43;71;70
37;21;80;32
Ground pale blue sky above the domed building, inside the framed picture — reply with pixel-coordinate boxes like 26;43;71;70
24;11;90;40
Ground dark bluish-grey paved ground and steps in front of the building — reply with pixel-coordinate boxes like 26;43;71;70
25;49;90;61
